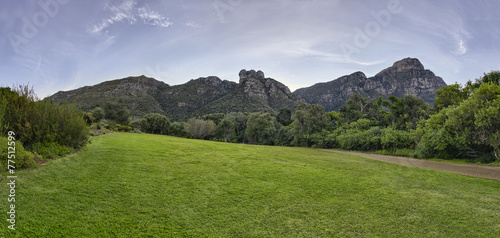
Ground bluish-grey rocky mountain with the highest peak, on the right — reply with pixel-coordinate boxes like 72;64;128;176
294;58;446;111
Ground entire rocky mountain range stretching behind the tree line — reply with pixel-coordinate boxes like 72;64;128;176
50;58;446;120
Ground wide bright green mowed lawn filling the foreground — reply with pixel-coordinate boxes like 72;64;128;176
0;133;500;237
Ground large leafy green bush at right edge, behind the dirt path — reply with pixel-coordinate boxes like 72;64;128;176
417;83;500;162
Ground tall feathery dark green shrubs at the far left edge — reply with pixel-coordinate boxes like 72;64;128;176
1;86;88;148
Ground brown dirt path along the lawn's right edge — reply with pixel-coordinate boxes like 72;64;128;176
325;150;500;180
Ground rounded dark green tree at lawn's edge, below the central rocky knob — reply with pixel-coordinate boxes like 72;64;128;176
246;113;278;145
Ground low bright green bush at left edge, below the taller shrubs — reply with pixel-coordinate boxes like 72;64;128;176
0;137;36;171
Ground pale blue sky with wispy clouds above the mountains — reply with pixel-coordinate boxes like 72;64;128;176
0;0;500;98
